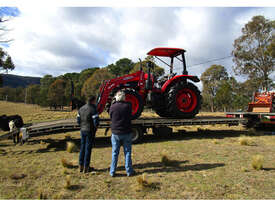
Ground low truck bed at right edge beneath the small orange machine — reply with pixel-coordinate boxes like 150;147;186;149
226;112;275;130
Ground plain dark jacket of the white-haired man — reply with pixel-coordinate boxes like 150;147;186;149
109;101;132;135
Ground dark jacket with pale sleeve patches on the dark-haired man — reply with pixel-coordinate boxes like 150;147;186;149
77;104;99;132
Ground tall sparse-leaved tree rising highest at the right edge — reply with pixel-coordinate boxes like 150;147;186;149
232;16;275;89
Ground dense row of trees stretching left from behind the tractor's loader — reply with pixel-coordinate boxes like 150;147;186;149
0;58;164;107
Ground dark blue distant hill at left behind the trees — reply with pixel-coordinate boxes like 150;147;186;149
1;74;41;88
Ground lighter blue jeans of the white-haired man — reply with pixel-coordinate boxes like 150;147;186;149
110;133;133;175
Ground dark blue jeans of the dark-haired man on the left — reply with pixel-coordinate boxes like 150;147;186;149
79;131;95;168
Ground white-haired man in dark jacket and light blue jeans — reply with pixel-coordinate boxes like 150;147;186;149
109;91;135;177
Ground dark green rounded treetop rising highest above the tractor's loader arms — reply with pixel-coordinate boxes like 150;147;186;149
107;58;134;77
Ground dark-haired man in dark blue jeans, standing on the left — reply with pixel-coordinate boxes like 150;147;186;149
77;96;99;173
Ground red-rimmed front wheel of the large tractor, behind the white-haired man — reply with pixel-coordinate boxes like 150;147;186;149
124;89;144;119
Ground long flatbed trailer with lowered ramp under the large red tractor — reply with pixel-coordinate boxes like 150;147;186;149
0;116;246;143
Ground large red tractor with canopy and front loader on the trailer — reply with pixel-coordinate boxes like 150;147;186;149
97;48;201;119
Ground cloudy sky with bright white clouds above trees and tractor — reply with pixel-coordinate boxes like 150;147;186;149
0;3;275;88
